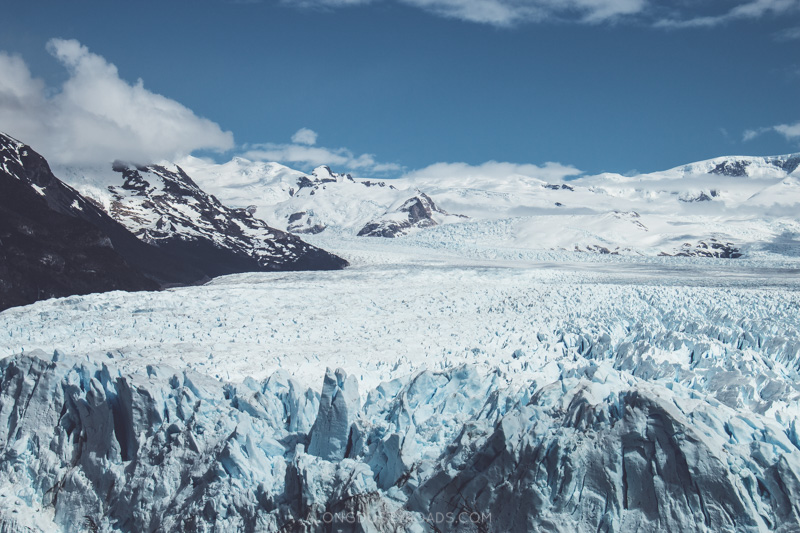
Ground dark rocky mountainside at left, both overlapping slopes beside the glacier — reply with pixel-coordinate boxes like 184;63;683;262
0;134;347;310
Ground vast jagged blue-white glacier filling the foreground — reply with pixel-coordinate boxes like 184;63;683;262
0;235;800;532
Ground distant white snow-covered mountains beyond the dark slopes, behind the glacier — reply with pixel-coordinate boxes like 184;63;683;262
181;154;800;258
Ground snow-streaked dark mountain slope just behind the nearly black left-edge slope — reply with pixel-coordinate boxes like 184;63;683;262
59;163;347;276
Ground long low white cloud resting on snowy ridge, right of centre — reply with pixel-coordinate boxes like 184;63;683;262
403;161;582;183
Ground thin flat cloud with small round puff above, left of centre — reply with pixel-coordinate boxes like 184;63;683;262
242;133;403;174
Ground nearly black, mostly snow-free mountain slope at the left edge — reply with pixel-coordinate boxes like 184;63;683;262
0;134;165;310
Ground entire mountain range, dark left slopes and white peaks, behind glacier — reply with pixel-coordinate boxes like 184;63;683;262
0;126;800;308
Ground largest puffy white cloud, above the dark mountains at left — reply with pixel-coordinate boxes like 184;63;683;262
0;39;233;165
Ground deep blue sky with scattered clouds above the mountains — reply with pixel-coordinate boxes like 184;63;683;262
0;0;800;177
